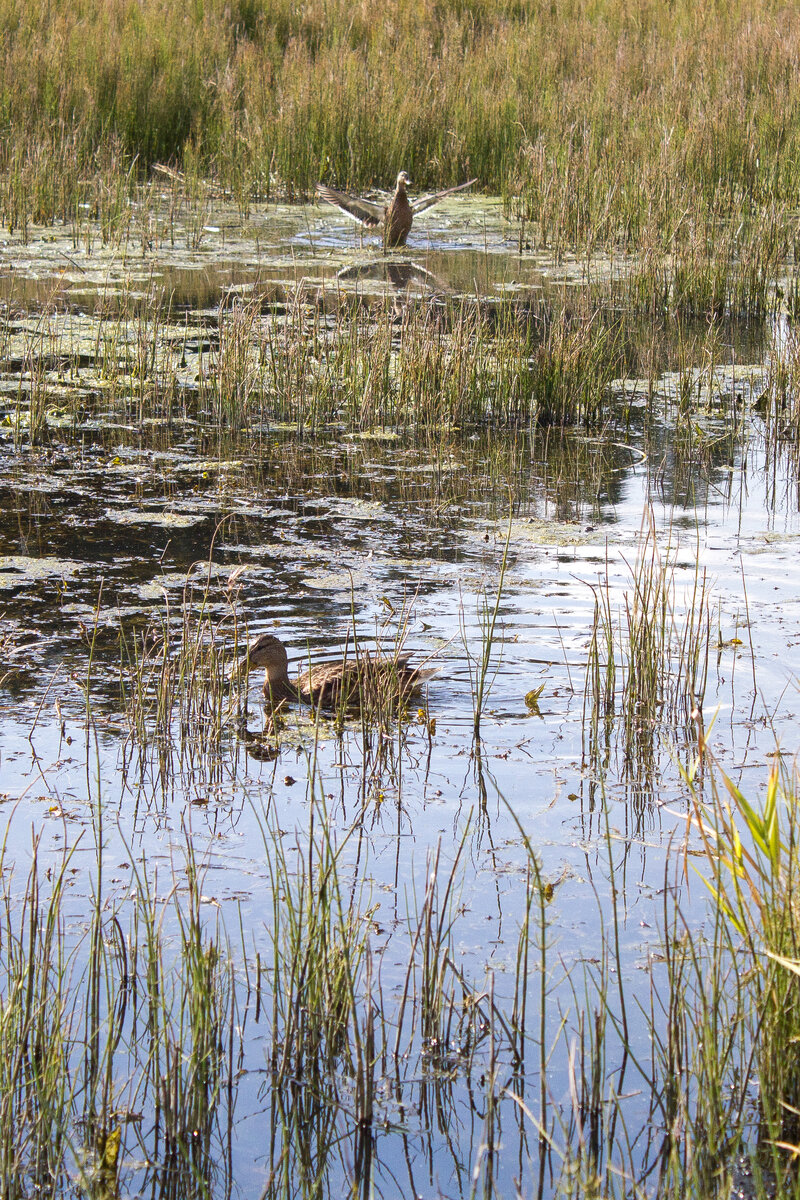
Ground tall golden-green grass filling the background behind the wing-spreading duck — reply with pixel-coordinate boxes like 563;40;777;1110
0;0;800;264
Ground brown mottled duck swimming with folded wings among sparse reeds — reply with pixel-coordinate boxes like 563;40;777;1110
241;634;435;708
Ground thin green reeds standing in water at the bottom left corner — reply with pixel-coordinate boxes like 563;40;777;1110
0;825;235;1196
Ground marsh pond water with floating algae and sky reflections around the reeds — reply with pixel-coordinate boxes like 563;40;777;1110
0;198;800;1196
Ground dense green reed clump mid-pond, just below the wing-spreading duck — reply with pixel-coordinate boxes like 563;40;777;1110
253;304;624;432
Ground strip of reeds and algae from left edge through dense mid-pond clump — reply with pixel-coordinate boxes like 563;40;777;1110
7;289;626;444
